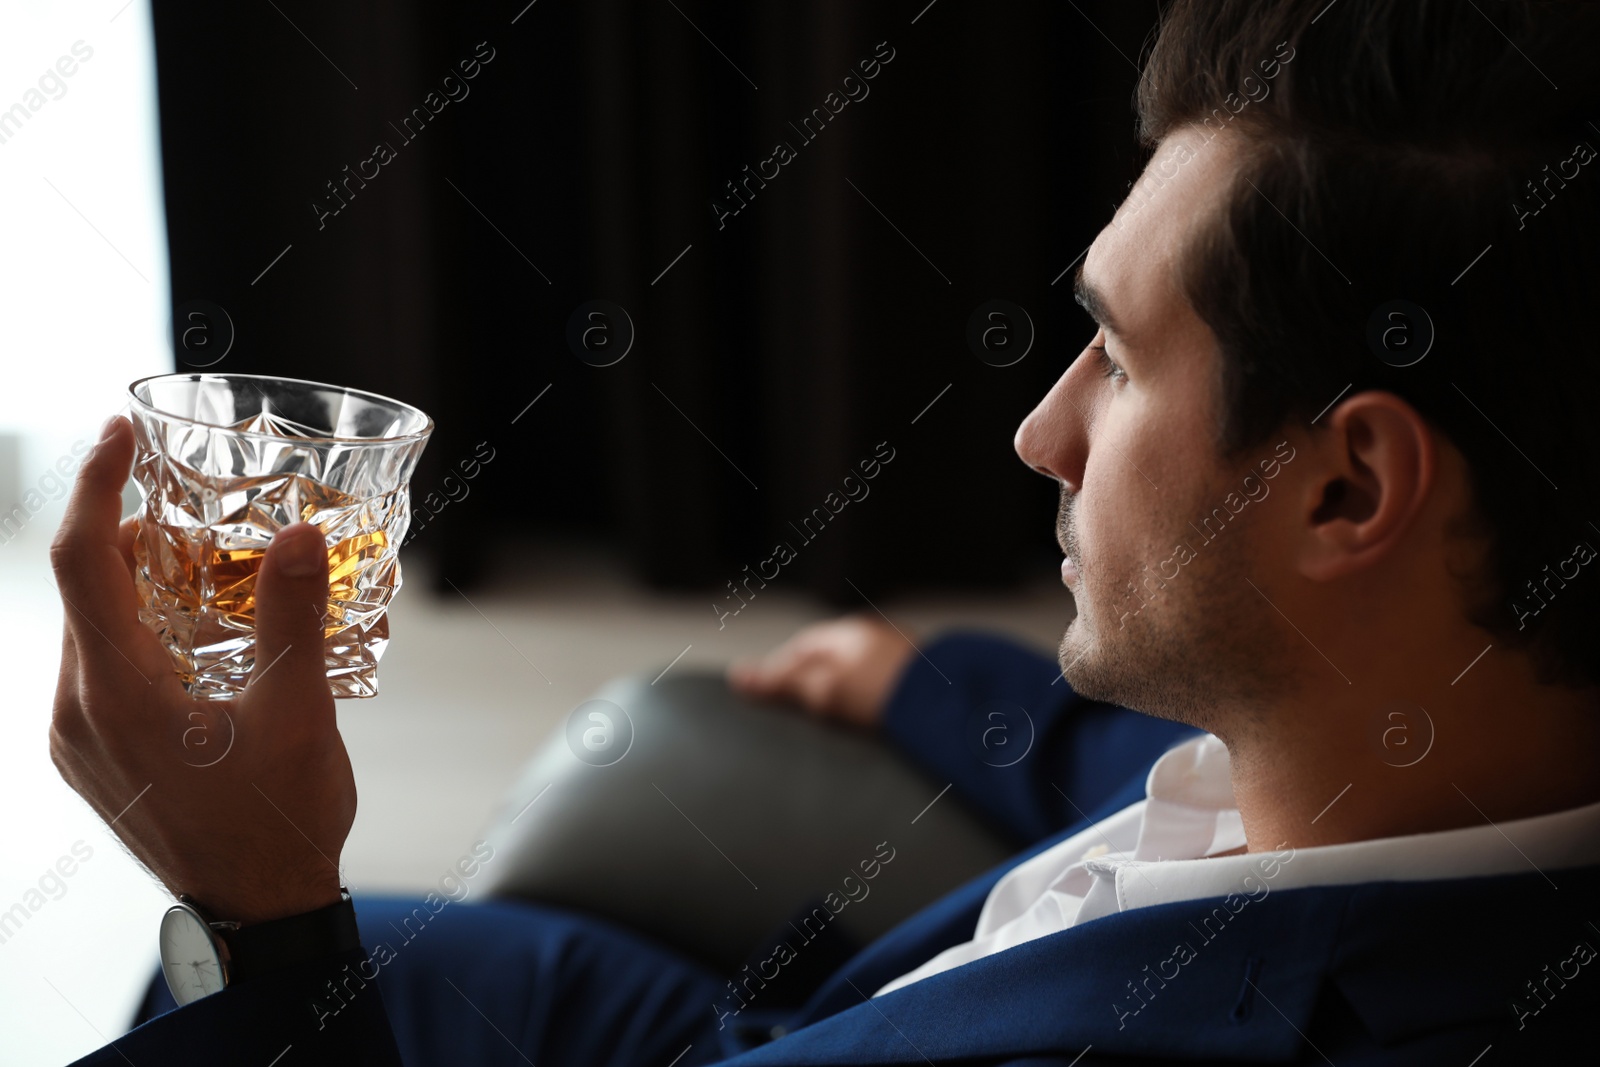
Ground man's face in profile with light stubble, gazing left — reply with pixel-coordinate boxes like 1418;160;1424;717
1016;128;1288;729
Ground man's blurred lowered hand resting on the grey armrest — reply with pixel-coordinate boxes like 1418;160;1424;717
728;616;917;726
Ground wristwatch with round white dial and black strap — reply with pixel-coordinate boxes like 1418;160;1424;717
160;886;362;1008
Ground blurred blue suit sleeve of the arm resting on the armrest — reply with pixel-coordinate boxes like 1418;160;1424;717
883;632;1195;845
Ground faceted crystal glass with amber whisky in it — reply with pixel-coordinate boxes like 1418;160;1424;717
128;374;434;699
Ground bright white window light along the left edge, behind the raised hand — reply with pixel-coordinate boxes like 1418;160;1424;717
0;0;171;1067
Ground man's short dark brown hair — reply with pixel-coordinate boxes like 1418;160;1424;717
1138;0;1600;685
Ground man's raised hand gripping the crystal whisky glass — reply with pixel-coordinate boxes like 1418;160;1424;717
50;418;355;923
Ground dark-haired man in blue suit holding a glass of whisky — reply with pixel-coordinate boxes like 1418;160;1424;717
51;0;1600;1067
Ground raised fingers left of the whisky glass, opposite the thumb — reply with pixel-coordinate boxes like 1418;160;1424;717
50;418;147;654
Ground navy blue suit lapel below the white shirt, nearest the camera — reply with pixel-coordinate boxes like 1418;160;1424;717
734;888;1350;1064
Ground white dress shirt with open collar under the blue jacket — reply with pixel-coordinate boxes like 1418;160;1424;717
874;734;1600;997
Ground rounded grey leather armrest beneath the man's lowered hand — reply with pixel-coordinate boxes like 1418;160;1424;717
467;672;1011;969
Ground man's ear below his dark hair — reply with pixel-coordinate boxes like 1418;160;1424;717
1299;392;1438;581
